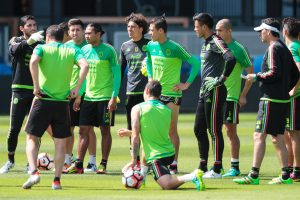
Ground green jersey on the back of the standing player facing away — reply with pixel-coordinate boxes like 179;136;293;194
33;42;84;101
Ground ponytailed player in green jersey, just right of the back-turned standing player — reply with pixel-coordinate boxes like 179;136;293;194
64;23;121;174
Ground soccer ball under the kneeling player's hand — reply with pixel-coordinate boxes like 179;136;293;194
122;169;143;189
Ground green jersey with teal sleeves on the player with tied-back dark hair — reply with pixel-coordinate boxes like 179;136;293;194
82;42;121;101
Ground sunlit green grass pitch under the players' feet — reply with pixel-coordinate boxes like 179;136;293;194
0;114;300;200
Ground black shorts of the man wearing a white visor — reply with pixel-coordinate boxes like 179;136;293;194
255;100;289;136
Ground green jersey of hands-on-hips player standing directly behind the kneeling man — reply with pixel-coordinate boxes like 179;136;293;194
147;39;200;97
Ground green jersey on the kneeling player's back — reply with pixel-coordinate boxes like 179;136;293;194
138;100;175;162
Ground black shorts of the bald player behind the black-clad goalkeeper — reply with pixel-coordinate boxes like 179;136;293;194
224;101;240;124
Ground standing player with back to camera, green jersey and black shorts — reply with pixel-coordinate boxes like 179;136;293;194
22;25;88;190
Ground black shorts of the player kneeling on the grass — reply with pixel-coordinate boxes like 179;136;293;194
148;155;175;181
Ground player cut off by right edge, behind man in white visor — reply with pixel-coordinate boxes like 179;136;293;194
282;18;300;180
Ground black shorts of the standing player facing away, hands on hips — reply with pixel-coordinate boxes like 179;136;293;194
25;99;71;138
